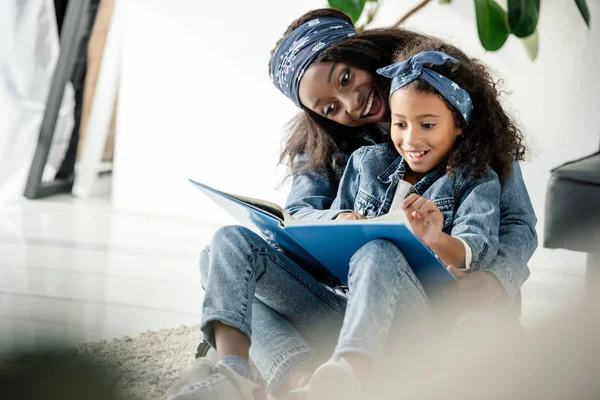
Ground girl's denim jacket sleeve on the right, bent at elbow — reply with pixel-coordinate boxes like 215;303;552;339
451;170;500;269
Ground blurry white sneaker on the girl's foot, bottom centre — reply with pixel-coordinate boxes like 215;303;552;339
308;357;363;400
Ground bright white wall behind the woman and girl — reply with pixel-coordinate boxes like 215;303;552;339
113;0;600;265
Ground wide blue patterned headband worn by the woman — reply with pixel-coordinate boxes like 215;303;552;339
271;17;356;108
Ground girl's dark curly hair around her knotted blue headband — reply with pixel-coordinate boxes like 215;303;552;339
395;38;527;182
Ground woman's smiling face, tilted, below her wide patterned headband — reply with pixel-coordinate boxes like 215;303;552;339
298;62;388;127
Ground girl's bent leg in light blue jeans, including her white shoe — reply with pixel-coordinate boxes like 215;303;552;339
308;240;432;400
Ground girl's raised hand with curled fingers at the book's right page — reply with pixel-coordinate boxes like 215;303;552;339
400;193;444;247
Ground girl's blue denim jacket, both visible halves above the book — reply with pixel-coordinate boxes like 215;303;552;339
331;143;500;269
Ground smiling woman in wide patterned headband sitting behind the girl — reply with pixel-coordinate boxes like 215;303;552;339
166;9;537;399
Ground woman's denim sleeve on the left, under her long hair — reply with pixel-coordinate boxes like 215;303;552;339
285;154;352;220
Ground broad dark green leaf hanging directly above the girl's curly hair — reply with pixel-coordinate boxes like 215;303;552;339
475;0;510;51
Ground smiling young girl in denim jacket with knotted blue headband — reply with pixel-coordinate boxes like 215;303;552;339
309;43;525;399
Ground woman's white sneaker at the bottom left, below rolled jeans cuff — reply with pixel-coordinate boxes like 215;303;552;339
169;360;266;400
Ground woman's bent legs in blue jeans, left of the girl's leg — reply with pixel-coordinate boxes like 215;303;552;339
201;226;345;389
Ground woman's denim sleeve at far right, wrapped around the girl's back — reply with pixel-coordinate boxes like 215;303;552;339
482;161;538;300
